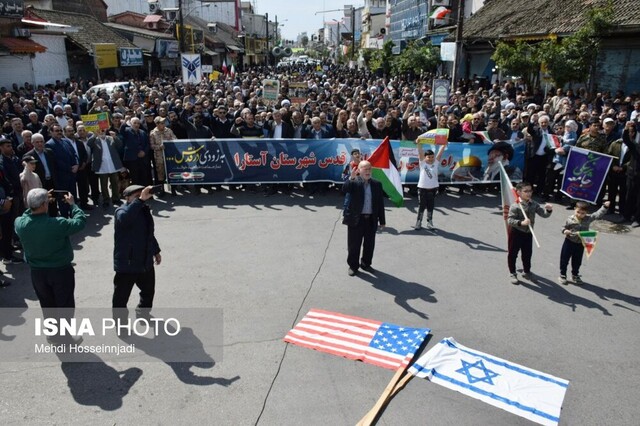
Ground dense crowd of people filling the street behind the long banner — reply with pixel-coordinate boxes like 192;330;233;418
0;65;640;282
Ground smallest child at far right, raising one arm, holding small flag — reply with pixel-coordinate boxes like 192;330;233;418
560;201;611;285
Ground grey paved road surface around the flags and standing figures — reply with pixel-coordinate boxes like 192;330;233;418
0;188;640;425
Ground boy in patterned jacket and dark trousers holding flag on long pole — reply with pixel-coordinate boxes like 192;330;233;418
507;182;553;285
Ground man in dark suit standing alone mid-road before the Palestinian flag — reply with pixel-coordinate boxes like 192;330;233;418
342;161;386;276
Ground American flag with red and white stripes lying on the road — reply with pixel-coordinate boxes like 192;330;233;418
284;309;431;370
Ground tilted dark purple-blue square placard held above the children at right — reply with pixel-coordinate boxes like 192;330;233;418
562;147;613;203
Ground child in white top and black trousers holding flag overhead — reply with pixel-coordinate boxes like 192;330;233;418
415;139;446;230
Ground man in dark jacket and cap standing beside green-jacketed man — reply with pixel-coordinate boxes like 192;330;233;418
112;185;162;313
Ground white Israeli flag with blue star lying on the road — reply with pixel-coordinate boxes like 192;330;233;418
409;337;569;425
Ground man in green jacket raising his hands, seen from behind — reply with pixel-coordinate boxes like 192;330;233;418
15;188;87;311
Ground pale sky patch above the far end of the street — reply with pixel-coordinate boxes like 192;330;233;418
251;0;364;40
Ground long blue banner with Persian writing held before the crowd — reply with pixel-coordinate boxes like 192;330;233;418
164;139;524;184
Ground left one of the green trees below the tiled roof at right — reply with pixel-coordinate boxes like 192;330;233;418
491;40;542;87
